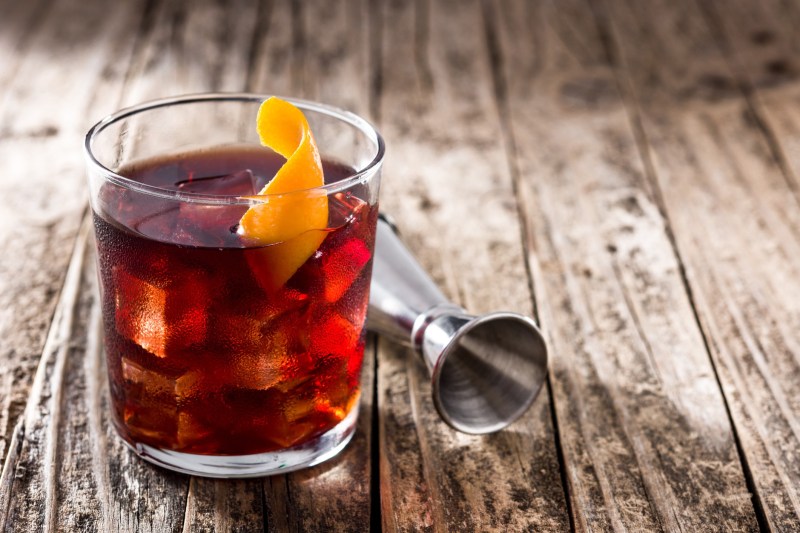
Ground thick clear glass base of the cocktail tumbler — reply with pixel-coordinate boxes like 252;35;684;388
124;404;358;478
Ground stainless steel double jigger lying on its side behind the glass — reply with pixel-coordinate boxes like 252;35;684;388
367;215;547;434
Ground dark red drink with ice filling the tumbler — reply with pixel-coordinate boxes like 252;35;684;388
94;147;377;455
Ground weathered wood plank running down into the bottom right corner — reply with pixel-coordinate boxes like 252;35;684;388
598;1;800;531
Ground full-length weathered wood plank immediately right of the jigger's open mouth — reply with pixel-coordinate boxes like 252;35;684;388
488;0;757;531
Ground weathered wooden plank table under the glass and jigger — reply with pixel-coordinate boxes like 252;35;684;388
0;0;800;532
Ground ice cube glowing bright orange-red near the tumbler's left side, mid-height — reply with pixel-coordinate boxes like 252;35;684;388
113;265;210;357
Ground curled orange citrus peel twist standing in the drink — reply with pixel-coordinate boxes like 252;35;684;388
239;97;328;290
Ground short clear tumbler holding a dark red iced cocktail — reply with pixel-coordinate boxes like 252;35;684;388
85;94;384;477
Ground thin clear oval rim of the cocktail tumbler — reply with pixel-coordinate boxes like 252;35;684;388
83;92;386;205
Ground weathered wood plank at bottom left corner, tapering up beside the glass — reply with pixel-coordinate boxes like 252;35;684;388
0;219;192;531
